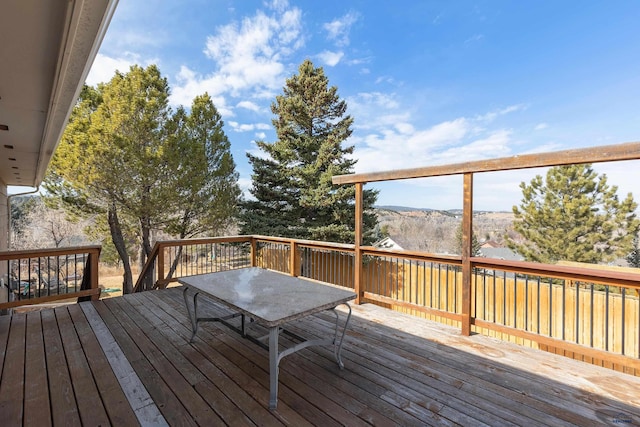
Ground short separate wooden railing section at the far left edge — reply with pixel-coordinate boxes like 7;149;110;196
0;246;101;310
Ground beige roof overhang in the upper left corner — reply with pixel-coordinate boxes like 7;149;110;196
0;0;118;187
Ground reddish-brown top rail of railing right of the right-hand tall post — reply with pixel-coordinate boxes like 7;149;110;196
471;257;640;289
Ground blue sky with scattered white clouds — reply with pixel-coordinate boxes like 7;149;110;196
87;0;640;210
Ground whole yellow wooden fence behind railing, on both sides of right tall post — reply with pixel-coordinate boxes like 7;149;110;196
364;258;640;375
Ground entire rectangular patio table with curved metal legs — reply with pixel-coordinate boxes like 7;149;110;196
178;267;356;409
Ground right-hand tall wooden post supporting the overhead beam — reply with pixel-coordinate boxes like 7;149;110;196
462;173;473;336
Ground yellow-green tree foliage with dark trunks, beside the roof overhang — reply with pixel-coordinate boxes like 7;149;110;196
45;65;240;290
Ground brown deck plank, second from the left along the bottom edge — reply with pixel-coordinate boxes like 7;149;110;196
24;311;52;426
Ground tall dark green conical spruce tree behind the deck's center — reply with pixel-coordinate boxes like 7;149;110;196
240;60;377;242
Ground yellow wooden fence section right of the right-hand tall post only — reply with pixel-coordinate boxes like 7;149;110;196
473;273;640;358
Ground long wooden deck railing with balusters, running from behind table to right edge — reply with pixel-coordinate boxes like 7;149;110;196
136;236;640;375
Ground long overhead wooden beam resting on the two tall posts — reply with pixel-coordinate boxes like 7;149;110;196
333;142;640;184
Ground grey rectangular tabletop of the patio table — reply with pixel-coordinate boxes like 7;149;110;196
178;267;356;327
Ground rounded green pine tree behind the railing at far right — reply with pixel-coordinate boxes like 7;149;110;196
507;164;640;264
